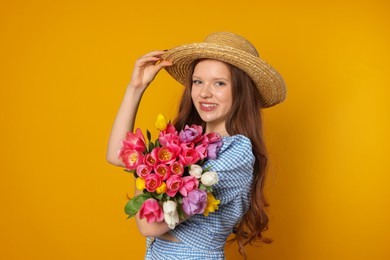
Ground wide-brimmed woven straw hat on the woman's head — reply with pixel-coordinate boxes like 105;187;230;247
162;32;286;108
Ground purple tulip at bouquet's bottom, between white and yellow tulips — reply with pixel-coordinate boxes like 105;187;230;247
182;190;207;217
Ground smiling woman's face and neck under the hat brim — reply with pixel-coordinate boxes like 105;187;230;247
191;60;233;132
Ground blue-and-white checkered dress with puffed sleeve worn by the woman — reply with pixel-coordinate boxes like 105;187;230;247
145;135;255;260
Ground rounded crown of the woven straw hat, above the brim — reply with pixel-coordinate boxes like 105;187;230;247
204;32;259;57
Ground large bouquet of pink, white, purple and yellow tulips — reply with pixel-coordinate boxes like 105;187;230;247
118;114;222;229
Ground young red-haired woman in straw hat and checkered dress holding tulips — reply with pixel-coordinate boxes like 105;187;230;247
107;32;286;260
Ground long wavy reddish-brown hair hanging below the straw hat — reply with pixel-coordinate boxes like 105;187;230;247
174;60;272;259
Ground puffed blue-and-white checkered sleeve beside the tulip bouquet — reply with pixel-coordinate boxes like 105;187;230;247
209;135;255;206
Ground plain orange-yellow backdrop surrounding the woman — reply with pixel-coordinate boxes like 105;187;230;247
0;0;390;260
